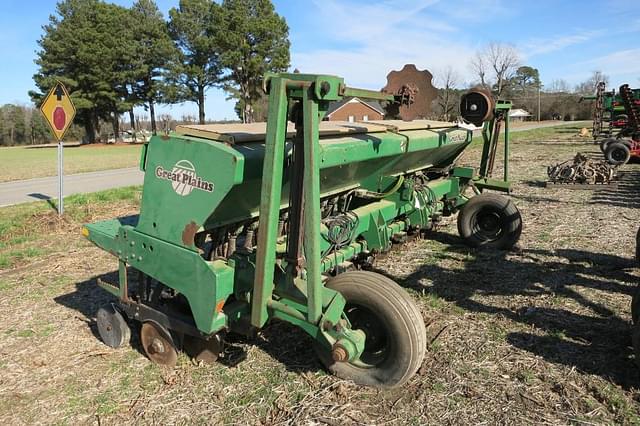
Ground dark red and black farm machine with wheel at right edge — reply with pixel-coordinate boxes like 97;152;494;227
599;84;640;165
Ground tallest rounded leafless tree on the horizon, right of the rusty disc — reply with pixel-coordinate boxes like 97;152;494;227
471;42;520;96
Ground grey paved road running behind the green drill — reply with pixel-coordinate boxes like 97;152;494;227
0;121;589;207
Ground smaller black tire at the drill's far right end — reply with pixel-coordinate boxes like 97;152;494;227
458;193;522;250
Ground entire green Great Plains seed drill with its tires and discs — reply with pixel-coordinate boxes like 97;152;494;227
83;67;522;387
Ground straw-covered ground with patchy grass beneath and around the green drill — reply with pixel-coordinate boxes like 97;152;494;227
0;127;640;425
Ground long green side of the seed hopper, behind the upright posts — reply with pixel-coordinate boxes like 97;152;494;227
201;127;471;228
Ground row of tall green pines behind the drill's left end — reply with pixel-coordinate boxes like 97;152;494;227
29;0;290;142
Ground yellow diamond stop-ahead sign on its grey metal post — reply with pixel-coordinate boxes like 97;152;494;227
40;82;76;216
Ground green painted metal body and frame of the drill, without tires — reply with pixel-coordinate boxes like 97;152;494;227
86;69;510;370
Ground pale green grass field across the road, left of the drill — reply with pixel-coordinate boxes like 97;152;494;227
0;145;140;182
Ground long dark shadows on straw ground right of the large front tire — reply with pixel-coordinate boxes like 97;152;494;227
378;233;640;388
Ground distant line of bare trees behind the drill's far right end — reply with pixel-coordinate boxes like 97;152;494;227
433;43;609;121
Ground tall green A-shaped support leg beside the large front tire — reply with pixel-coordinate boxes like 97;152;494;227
251;76;365;359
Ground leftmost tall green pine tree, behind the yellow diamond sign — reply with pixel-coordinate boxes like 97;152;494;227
30;0;135;141
